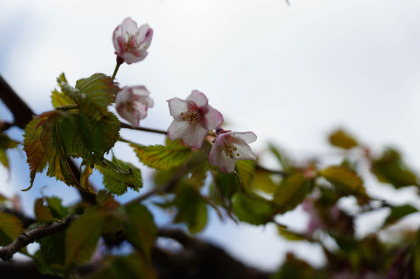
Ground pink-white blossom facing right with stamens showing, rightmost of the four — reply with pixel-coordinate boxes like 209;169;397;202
209;129;257;172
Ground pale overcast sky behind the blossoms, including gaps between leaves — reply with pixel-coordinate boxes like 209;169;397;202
0;0;420;268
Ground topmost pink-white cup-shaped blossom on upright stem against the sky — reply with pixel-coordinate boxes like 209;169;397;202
112;17;153;64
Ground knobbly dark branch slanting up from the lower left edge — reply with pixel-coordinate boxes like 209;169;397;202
0;215;78;261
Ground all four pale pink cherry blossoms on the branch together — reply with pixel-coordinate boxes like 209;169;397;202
113;18;257;172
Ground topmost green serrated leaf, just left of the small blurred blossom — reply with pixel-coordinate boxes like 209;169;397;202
57;73;119;120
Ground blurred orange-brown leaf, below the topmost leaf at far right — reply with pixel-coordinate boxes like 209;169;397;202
320;166;366;195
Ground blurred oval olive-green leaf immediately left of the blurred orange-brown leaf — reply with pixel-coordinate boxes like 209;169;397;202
273;173;312;213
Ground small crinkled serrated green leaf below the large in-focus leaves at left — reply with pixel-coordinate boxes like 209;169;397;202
95;157;143;195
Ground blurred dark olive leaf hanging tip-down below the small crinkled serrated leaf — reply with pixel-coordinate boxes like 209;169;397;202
124;203;157;260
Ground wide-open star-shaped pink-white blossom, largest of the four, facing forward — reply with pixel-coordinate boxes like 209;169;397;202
168;90;223;148
